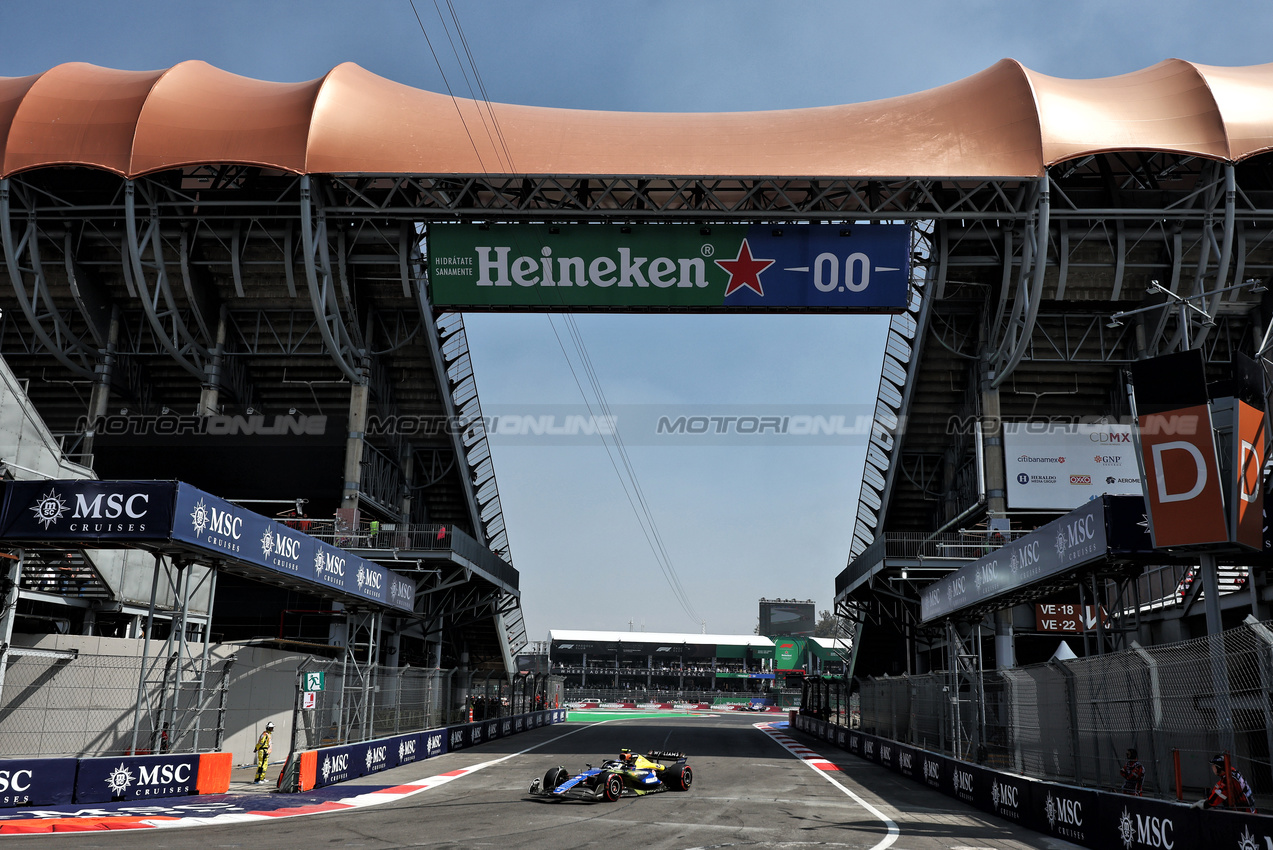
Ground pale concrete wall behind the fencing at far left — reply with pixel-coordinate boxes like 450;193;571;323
0;635;308;765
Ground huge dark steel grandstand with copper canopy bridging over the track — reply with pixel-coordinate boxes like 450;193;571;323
0;60;1273;702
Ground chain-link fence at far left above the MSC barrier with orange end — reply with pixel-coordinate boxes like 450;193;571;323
0;649;234;757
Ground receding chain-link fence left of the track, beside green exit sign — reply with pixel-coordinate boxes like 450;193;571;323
292;659;563;751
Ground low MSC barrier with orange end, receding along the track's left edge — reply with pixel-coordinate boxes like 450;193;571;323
288;709;565;791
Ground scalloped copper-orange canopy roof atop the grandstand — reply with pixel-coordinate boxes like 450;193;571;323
0;60;1273;178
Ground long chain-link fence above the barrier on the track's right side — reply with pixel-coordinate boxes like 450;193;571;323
845;620;1273;798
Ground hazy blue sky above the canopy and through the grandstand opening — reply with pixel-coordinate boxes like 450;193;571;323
0;0;1273;639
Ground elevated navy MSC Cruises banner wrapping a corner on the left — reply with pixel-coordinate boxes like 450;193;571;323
0;480;415;611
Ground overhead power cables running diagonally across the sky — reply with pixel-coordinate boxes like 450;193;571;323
410;0;705;625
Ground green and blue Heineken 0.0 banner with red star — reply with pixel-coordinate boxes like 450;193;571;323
426;224;910;313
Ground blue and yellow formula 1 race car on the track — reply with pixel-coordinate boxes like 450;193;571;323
531;749;694;803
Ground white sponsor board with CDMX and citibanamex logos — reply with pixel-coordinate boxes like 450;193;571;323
1003;422;1142;510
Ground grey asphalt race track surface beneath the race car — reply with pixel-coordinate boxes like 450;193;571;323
17;714;1074;850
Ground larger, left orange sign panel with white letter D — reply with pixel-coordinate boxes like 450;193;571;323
1139;405;1228;548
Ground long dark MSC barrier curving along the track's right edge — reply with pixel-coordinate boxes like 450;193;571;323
792;715;1273;850
